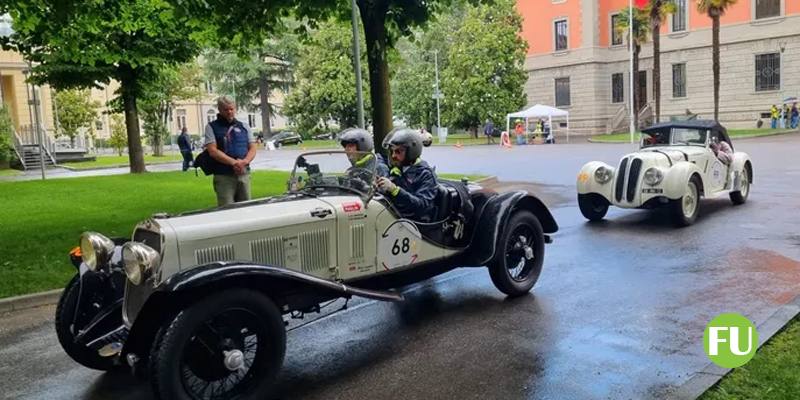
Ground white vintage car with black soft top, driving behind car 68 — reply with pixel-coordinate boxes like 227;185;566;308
577;120;753;226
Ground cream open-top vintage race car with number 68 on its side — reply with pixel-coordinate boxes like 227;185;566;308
56;152;558;399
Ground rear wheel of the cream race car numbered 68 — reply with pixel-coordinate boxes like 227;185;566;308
489;210;544;297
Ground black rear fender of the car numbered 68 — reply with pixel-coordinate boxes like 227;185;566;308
462;191;558;266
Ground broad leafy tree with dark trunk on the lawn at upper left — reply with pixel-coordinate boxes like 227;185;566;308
0;0;206;173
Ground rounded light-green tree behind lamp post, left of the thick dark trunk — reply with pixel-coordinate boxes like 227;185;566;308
284;21;369;136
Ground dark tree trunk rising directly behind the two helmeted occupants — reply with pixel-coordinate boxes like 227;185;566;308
358;0;392;156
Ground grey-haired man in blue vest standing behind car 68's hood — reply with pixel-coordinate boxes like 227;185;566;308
203;96;256;206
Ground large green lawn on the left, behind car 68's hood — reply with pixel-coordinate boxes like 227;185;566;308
0;171;288;298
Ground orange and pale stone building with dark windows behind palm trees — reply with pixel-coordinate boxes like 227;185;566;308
517;0;800;134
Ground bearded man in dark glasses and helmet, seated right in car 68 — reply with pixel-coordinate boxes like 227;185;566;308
377;129;438;222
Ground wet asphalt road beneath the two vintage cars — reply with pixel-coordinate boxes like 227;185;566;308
0;134;800;399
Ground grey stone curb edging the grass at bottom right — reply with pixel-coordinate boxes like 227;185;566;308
672;295;800;400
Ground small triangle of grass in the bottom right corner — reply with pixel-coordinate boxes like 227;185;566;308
700;317;800;400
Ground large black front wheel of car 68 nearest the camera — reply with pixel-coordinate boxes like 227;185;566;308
149;289;286;400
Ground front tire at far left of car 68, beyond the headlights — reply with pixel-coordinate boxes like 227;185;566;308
56;274;117;371
